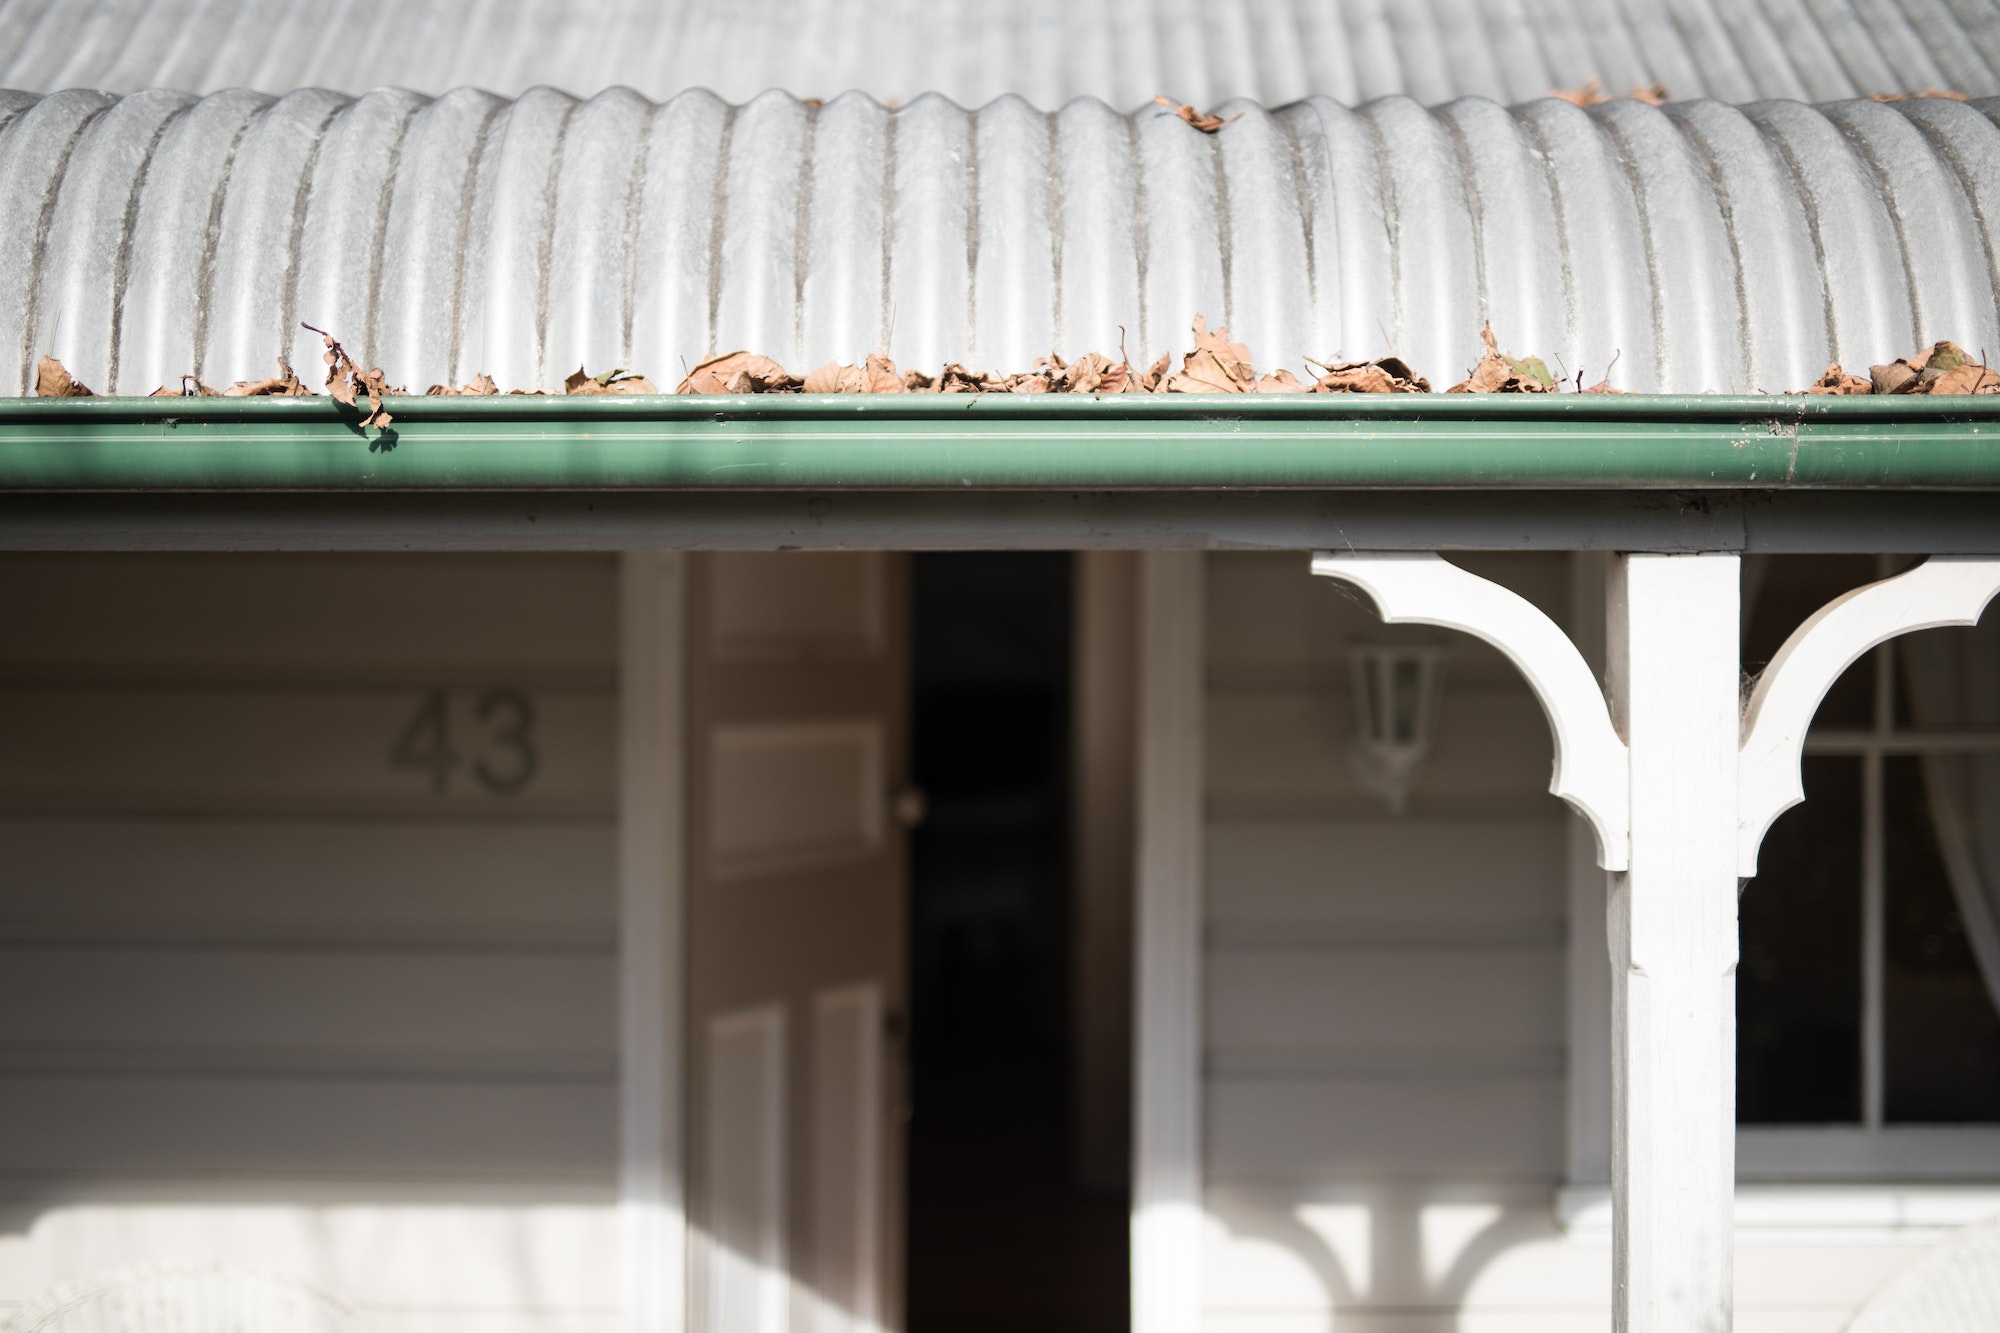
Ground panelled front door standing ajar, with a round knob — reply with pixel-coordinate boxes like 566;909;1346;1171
688;552;910;1333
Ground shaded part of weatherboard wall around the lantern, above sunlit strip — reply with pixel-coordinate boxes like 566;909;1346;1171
1204;552;1568;1203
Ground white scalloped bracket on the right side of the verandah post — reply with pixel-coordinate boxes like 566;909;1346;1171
1736;556;2000;877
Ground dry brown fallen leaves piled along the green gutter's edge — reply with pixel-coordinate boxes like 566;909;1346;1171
34;314;2000;404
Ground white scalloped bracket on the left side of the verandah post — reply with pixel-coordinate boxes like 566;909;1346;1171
1312;550;1632;871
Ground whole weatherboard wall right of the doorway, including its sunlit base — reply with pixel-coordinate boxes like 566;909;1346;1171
1202;552;1936;1333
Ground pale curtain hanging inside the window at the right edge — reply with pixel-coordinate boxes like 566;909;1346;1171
1900;610;2000;1005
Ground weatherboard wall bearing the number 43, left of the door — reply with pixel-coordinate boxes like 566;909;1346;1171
0;556;618;1333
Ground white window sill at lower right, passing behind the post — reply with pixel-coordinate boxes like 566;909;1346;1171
1556;1183;2000;1245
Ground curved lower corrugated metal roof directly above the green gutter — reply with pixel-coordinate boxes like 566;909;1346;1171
0;90;2000;394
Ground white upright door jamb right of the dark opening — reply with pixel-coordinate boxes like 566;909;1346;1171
1132;550;1206;1333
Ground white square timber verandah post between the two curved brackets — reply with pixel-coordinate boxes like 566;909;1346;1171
1606;554;1740;1333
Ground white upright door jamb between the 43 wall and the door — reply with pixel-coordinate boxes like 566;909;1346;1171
618;550;688;1333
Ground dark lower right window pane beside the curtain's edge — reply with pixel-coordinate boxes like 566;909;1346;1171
1882;757;2000;1123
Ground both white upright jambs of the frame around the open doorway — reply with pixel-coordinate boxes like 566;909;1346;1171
618;550;1204;1333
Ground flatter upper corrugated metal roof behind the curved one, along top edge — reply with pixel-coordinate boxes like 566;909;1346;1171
11;0;2000;108
